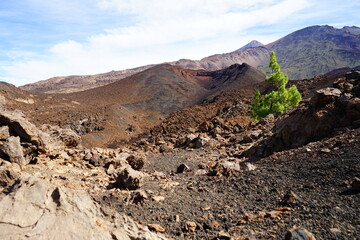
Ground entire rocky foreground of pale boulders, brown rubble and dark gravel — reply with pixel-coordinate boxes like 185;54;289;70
0;71;360;240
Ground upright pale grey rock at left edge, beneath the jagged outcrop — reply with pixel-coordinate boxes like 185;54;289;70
0;136;28;166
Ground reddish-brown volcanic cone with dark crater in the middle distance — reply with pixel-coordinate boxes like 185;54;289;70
1;64;265;146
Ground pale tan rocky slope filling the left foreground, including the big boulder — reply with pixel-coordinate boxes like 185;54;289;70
0;106;166;240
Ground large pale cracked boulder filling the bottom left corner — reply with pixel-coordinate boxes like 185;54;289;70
0;174;166;240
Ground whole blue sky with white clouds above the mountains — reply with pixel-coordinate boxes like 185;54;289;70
0;0;360;86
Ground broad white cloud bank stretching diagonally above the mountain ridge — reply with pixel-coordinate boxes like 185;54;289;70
2;0;308;85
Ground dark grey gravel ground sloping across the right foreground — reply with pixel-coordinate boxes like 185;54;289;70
97;129;360;239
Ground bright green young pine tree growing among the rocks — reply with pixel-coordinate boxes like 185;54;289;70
250;51;302;121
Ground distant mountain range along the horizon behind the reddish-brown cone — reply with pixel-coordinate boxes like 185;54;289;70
21;26;360;93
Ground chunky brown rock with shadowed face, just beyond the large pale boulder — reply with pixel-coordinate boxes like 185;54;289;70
115;166;144;190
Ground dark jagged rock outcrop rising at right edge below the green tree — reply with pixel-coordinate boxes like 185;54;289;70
244;71;360;157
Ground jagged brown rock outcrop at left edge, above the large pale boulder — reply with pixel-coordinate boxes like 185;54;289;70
0;109;81;167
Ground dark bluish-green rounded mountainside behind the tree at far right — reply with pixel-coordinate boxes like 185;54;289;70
263;26;360;79
